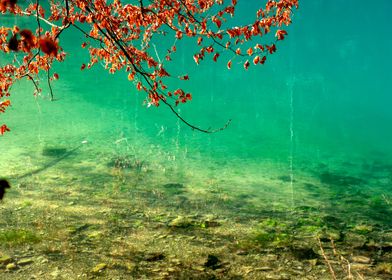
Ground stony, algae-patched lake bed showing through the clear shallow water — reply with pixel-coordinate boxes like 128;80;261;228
0;145;392;279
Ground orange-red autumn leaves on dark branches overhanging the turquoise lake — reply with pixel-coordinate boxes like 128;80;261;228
0;0;298;134
